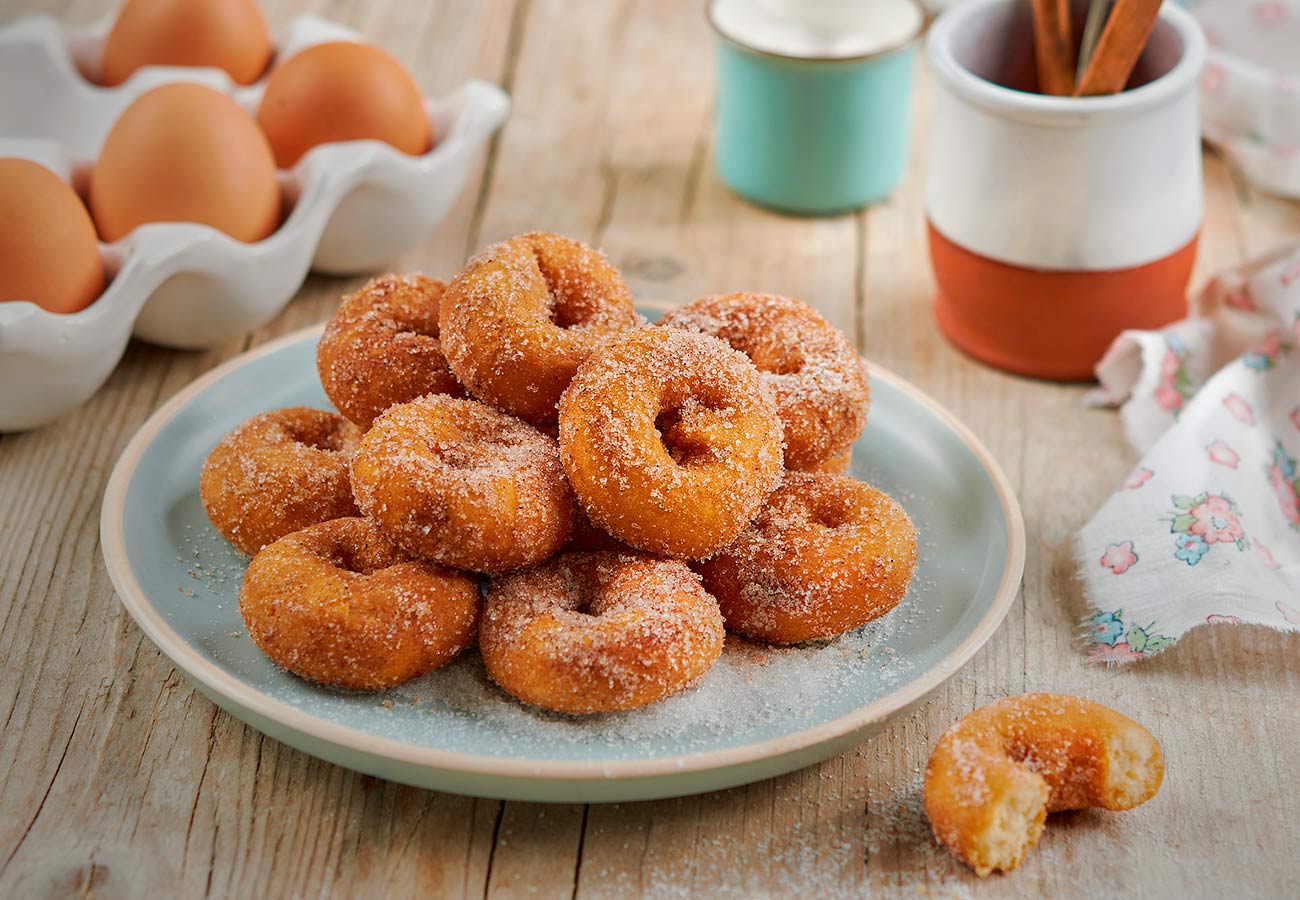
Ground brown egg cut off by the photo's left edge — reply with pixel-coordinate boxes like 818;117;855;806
0;159;104;312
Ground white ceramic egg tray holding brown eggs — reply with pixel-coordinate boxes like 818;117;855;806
0;16;510;430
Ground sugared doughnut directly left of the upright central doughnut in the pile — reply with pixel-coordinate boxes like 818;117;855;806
352;394;573;572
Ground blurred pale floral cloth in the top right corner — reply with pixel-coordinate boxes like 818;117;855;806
1182;0;1300;196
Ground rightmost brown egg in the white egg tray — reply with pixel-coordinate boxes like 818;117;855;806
257;40;433;169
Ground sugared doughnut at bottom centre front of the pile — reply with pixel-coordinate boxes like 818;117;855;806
478;553;725;713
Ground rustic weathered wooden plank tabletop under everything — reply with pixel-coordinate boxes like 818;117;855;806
0;0;1300;899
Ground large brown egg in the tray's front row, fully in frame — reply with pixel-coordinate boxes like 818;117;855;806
90;83;280;242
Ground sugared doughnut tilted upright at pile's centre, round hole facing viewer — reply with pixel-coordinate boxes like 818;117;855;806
560;328;781;559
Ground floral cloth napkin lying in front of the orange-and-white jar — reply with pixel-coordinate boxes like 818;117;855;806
1075;245;1300;662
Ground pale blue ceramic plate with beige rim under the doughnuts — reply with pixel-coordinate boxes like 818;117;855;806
100;326;1024;801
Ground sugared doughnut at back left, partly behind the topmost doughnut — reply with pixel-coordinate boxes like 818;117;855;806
316;274;465;428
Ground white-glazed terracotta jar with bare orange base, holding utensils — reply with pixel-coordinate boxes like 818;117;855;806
926;0;1205;380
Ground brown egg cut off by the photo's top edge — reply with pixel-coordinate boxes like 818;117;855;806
99;0;272;85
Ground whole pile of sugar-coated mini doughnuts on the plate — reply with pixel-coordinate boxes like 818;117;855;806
200;233;917;714
